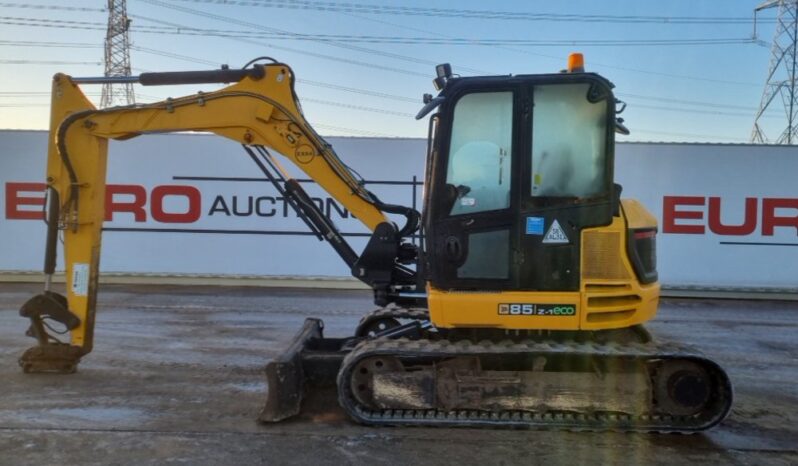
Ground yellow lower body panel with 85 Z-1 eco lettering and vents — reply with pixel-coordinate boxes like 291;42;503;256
427;216;660;330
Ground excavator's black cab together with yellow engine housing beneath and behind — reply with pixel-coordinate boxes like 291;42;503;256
419;58;659;331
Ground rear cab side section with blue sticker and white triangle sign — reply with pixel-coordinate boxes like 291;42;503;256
518;80;614;291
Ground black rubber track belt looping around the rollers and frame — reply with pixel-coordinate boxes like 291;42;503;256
338;339;733;433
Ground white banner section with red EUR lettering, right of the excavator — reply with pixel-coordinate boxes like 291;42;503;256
615;143;798;290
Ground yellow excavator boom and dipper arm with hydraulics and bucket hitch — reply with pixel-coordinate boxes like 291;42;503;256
20;63;417;372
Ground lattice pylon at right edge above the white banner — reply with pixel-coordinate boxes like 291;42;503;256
751;0;798;144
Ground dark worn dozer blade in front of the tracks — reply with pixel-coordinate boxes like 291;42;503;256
258;318;357;423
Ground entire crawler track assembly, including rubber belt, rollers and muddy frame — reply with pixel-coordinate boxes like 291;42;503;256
337;338;732;433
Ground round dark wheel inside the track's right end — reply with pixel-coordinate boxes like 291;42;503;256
654;360;712;416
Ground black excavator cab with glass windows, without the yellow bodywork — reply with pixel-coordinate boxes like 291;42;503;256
424;73;618;291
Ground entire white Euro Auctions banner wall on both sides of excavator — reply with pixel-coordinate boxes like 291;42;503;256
0;131;798;290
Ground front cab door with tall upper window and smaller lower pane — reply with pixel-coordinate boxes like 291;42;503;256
426;84;523;290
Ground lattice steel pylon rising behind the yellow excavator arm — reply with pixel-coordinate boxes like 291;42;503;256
100;0;136;108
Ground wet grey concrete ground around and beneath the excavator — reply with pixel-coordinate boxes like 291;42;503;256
0;284;798;465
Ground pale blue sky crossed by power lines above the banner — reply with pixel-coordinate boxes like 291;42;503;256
0;0;786;143
